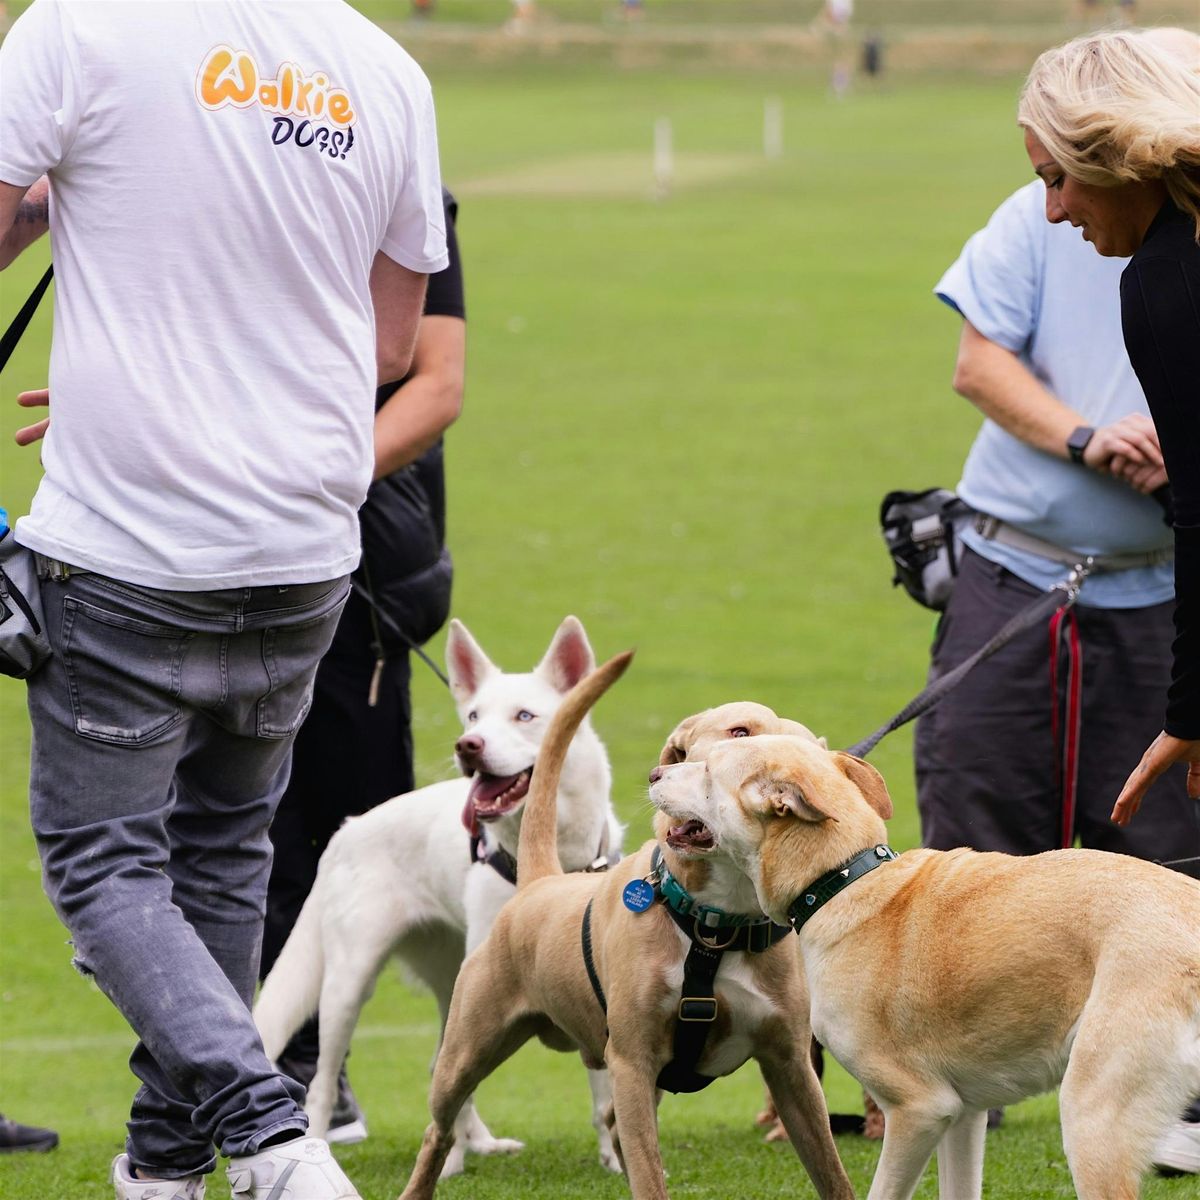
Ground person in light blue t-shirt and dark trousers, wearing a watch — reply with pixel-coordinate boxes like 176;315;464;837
914;181;1200;883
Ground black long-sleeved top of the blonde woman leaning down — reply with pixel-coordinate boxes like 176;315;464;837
1121;200;1200;740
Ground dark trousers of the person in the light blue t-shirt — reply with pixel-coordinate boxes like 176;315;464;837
914;550;1200;874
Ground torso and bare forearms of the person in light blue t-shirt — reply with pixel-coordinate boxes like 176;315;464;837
935;181;1175;608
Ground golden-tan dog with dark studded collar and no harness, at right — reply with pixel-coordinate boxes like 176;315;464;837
650;737;1200;1200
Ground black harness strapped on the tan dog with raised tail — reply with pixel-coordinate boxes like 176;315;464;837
580;846;792;1092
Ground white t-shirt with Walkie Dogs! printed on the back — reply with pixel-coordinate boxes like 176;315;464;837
0;0;446;590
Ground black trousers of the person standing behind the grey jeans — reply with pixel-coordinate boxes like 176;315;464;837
259;593;414;1061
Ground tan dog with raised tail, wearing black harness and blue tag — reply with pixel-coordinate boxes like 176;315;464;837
402;654;853;1200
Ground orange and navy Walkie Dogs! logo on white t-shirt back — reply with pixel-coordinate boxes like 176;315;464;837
196;46;356;158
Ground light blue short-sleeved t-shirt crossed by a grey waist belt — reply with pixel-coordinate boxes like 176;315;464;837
934;180;1175;608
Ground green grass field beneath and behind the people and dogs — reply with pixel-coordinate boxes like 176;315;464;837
0;18;1198;1200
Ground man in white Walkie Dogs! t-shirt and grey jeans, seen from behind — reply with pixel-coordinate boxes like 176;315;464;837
0;0;446;1200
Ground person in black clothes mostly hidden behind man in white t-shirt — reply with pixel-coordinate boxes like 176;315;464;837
259;192;467;1142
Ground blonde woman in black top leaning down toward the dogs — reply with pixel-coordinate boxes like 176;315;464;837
1018;23;1200;1172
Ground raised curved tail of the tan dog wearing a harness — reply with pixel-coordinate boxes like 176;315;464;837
517;650;634;892
